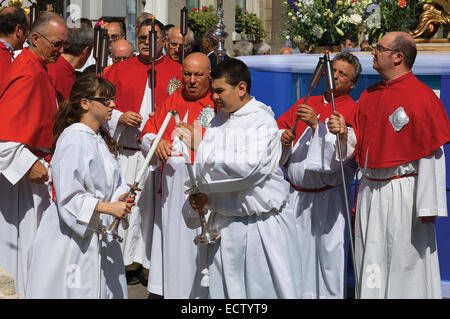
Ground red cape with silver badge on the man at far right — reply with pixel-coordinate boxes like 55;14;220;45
355;72;450;168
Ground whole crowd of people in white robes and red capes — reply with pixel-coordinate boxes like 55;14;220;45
0;7;450;299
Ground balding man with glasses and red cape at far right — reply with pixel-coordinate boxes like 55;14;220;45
328;32;450;299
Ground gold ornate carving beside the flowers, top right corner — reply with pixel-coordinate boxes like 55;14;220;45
409;0;450;38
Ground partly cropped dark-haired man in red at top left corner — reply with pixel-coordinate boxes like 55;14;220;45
0;7;30;77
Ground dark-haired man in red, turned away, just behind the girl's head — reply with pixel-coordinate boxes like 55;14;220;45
47;27;94;103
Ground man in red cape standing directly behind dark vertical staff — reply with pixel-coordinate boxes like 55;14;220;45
105;19;181;284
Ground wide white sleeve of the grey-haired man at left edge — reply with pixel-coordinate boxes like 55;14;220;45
0;141;38;185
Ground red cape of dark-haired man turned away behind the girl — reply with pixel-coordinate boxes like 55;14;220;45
47;56;75;103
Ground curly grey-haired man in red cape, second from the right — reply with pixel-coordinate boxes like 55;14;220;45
277;53;361;299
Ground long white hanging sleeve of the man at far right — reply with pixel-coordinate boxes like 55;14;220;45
416;147;447;217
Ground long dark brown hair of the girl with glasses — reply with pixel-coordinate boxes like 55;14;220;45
52;74;120;156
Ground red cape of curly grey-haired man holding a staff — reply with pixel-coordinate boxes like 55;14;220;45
277;94;356;144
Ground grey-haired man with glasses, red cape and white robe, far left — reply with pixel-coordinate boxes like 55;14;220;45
0;12;67;296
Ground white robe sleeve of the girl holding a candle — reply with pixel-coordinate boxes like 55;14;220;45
51;133;100;237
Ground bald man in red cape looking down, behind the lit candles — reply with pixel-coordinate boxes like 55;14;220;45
142;52;214;299
